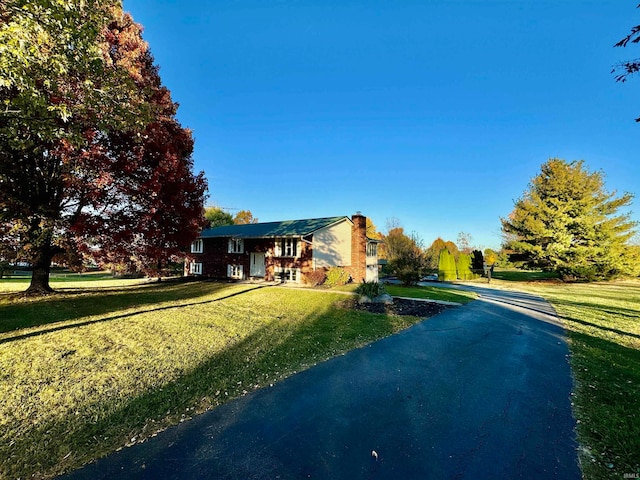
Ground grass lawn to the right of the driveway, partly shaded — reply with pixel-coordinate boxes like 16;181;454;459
503;282;640;479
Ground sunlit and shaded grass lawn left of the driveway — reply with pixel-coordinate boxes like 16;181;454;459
0;281;432;479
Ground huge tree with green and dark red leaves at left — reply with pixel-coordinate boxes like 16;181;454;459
0;0;206;293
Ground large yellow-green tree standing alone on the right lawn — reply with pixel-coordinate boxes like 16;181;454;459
501;158;636;280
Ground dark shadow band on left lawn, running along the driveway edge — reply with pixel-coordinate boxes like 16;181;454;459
6;296;394;478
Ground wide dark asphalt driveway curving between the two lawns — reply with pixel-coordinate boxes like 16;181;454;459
67;288;581;480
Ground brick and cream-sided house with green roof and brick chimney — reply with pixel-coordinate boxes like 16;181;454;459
185;212;379;283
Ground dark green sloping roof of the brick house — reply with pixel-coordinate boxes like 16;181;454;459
200;217;351;238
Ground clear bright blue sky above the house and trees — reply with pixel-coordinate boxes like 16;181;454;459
124;0;640;248
